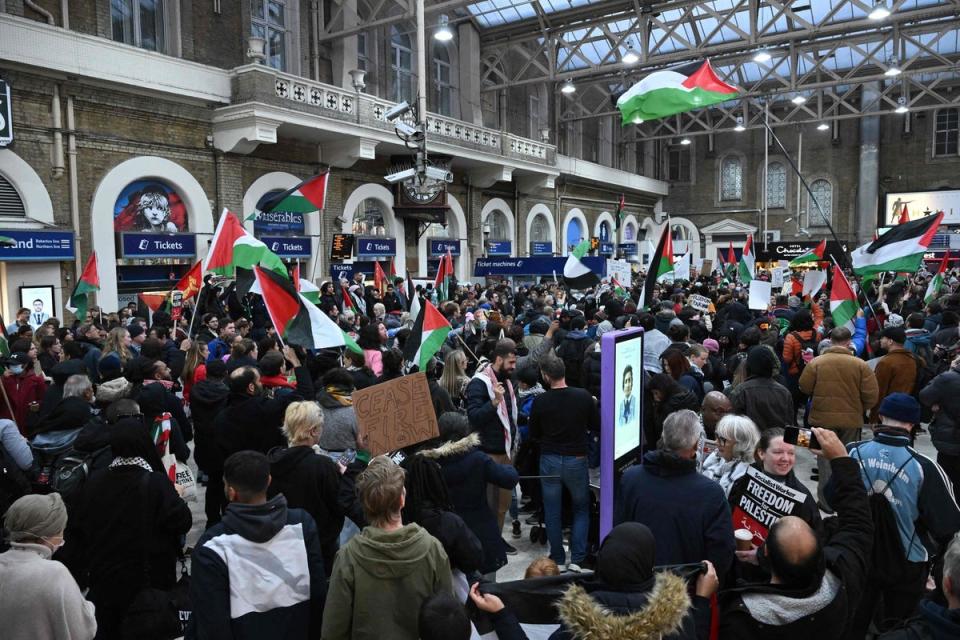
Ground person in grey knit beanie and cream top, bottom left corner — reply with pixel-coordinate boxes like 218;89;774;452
0;493;97;640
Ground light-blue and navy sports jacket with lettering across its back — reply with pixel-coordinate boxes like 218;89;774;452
848;429;960;562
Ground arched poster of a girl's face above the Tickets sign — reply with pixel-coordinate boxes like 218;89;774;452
113;180;188;233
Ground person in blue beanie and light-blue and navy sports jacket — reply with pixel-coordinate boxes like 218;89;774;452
840;392;960;638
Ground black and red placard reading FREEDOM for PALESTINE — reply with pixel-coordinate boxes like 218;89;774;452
730;467;807;546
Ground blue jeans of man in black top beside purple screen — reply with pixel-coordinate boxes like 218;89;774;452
540;453;590;565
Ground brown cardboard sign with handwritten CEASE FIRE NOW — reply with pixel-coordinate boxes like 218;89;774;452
353;373;440;456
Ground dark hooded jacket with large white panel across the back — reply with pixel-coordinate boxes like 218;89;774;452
186;494;327;640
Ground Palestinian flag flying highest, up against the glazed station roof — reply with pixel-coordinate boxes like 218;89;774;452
617;60;737;126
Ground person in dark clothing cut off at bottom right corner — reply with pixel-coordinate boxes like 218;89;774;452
879;533;960;640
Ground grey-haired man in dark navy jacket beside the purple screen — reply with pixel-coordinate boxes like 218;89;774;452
614;409;734;577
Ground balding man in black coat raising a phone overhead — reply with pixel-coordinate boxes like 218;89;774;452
720;428;873;640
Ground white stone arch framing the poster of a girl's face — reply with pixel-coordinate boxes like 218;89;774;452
89;156;214;312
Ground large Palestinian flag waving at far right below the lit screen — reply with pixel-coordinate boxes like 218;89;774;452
850;211;943;276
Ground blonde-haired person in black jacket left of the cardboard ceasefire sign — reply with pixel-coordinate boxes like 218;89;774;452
268;401;366;576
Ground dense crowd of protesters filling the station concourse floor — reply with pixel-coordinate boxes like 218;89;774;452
0;264;960;640
